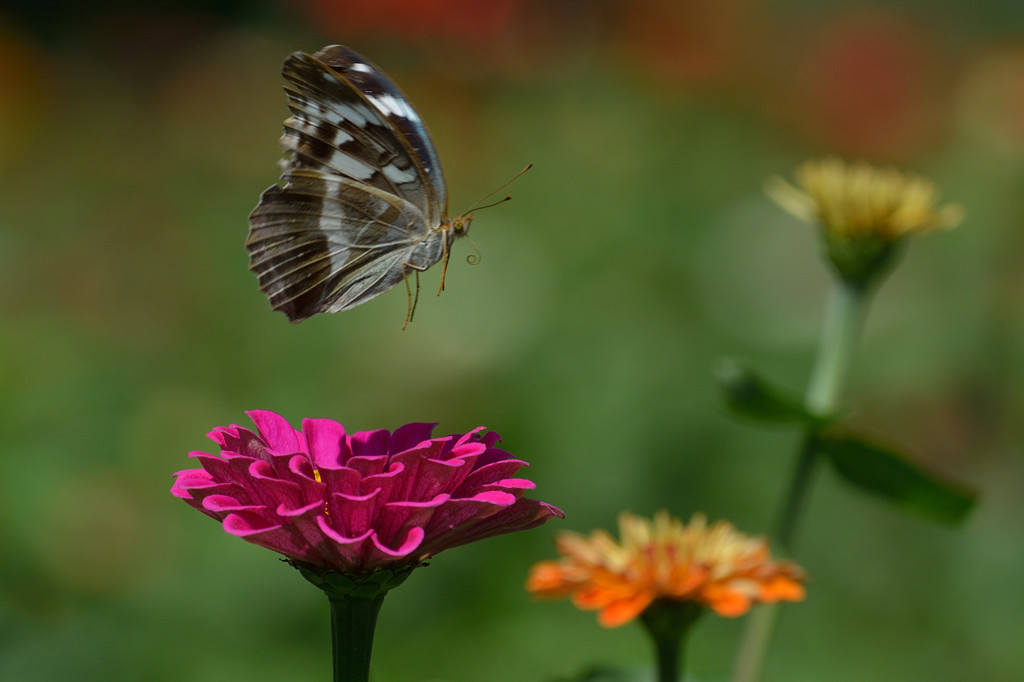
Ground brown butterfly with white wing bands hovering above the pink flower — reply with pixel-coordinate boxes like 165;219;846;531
246;45;472;324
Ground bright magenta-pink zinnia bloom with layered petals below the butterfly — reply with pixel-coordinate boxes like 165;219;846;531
171;410;564;576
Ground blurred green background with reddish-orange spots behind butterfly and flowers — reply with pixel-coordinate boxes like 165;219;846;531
0;0;1024;682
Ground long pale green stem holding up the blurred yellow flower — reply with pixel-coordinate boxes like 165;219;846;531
732;280;869;682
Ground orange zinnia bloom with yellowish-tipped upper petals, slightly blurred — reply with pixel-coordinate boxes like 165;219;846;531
526;510;804;628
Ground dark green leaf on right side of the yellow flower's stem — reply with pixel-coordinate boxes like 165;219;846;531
818;436;976;523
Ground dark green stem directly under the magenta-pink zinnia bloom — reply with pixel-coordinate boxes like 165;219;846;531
328;591;386;682
